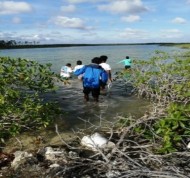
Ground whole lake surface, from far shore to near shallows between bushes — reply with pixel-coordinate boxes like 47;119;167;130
0;45;184;149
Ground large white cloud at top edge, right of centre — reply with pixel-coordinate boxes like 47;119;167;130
98;0;148;14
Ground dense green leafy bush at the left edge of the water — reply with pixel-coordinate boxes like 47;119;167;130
0;57;60;142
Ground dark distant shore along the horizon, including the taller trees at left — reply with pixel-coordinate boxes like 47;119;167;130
0;40;190;49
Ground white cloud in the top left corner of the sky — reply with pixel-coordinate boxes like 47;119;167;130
0;1;32;15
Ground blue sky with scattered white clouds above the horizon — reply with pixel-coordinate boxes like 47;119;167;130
0;0;190;44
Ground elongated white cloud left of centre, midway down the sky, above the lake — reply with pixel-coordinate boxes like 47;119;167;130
52;16;85;29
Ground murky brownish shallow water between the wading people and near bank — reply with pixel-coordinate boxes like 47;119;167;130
4;76;150;152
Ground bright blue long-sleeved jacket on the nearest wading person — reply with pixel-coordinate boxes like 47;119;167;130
74;64;108;88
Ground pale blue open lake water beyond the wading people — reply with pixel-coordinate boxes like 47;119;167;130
0;45;182;73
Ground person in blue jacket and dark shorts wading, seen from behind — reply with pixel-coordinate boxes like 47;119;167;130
74;57;108;102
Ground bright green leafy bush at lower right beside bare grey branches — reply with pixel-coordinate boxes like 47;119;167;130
153;103;190;153
